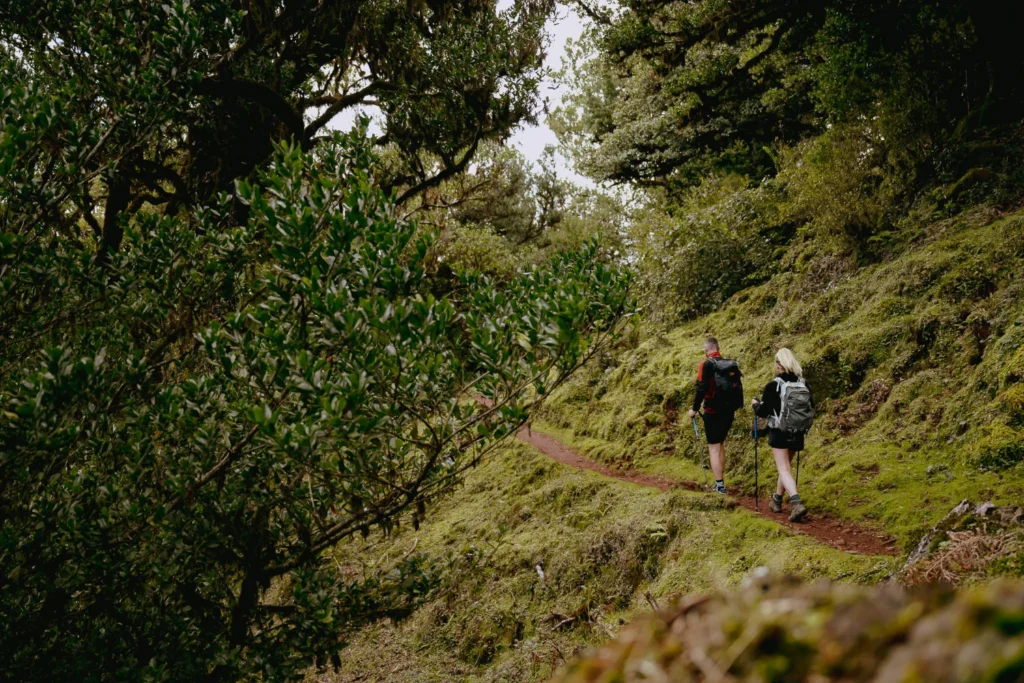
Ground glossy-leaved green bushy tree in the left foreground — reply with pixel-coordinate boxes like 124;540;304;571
0;135;630;681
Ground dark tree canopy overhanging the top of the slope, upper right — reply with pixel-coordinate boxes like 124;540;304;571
556;0;1003;186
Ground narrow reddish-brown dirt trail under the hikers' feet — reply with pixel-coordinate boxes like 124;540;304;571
517;427;897;555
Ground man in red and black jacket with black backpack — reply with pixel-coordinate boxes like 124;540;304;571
690;337;743;495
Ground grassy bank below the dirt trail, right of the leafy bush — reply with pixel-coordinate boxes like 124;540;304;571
311;443;898;682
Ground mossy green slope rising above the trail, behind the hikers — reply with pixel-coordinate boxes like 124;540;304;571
535;209;1024;550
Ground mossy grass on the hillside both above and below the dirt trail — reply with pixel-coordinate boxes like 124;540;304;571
311;193;1024;683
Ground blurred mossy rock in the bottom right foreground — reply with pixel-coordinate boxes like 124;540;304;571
557;577;1024;683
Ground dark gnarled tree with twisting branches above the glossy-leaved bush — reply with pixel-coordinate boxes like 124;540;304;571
0;0;551;258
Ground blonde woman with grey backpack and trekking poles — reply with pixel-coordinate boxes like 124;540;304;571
751;348;814;522
